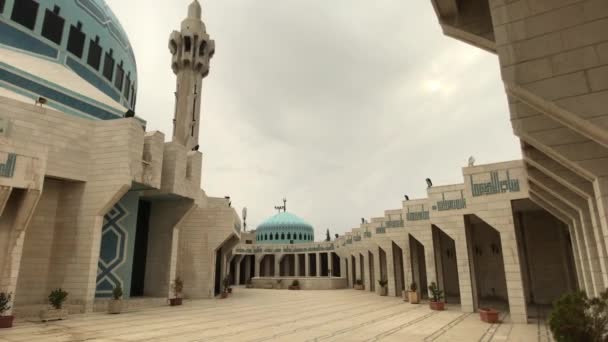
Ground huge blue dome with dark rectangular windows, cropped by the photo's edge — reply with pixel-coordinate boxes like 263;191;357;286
0;0;137;120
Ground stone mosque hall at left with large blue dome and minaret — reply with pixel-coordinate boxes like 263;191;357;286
0;0;241;316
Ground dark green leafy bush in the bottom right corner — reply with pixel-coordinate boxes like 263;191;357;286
549;291;608;342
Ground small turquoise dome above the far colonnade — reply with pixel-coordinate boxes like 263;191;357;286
255;212;315;244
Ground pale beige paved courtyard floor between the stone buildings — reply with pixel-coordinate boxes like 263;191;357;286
0;288;551;342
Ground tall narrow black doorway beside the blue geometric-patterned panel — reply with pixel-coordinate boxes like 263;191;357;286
130;201;150;297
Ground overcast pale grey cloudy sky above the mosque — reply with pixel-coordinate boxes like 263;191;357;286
107;0;520;238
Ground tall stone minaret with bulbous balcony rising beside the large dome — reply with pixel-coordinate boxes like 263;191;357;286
169;0;215;150
